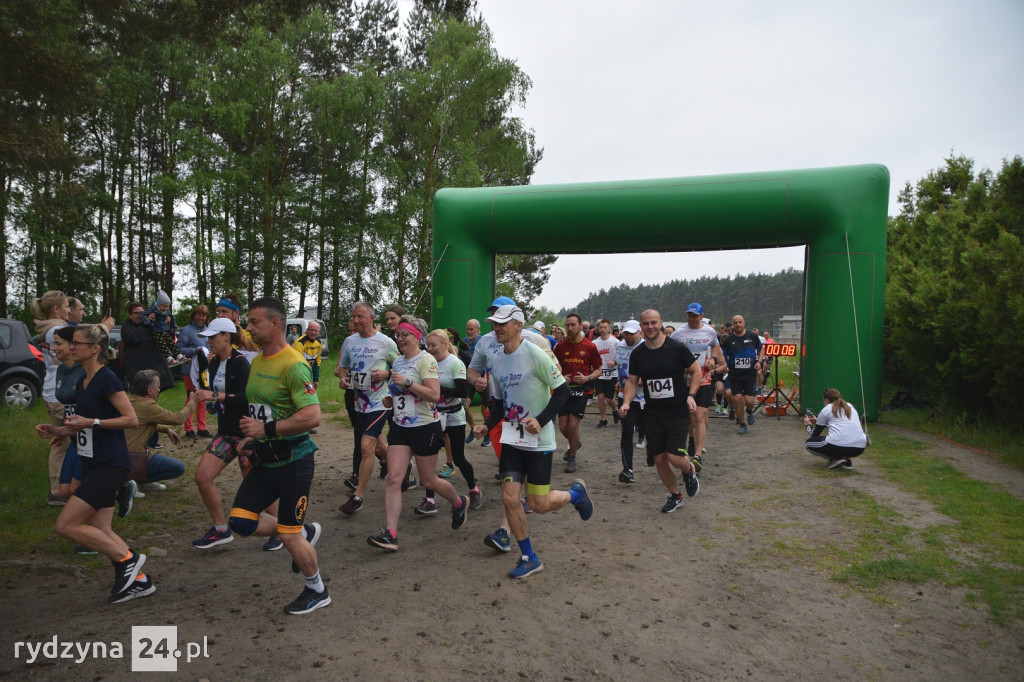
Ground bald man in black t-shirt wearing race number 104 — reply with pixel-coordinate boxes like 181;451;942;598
620;309;701;514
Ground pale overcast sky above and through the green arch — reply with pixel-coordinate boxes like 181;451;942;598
432;0;1024;310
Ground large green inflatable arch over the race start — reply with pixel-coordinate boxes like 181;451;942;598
432;165;889;421
